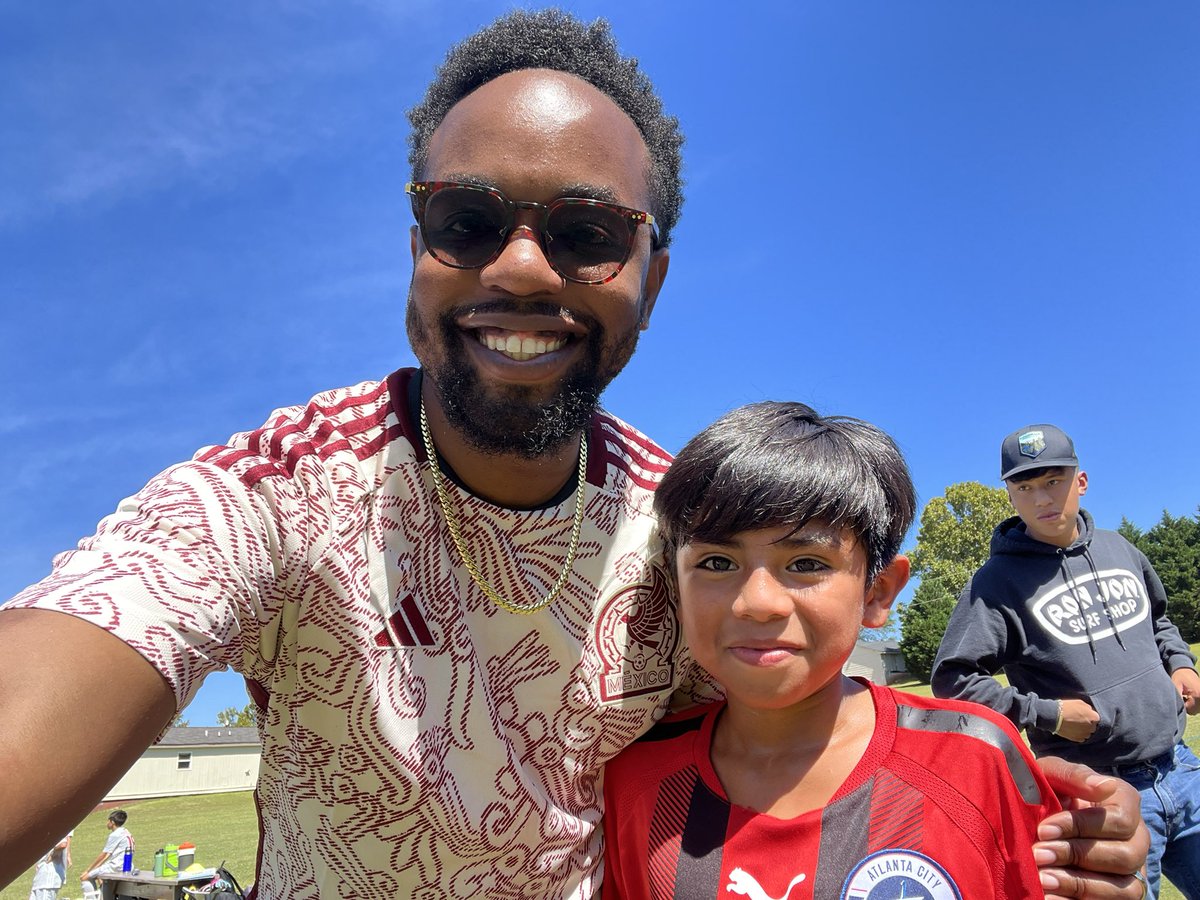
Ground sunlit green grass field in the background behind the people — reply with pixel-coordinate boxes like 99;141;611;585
0;644;1200;900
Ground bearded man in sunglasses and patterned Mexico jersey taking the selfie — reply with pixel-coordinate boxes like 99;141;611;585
0;11;1145;900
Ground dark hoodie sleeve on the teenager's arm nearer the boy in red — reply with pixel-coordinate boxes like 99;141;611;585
930;578;1058;731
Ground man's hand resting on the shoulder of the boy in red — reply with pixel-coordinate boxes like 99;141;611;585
1033;756;1150;900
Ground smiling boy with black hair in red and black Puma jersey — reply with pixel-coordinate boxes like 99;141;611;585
604;403;1057;900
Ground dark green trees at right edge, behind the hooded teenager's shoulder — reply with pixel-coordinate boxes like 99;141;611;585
1117;510;1200;643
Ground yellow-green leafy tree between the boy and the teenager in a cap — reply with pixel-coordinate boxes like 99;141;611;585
900;481;1013;680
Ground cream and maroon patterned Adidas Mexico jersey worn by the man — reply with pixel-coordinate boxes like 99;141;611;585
11;370;710;900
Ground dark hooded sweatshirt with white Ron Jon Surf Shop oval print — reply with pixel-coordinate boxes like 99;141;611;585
931;510;1195;766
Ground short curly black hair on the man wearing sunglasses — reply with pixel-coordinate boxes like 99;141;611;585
408;8;683;246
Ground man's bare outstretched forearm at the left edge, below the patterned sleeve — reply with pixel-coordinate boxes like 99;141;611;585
0;610;175;887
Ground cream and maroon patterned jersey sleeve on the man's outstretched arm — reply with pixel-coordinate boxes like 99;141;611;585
5;462;298;709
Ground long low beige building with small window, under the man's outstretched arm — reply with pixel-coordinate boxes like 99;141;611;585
104;726;260;803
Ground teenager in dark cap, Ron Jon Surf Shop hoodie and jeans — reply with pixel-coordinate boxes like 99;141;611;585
931;424;1200;898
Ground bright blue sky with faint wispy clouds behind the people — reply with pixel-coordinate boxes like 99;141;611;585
0;0;1200;724
